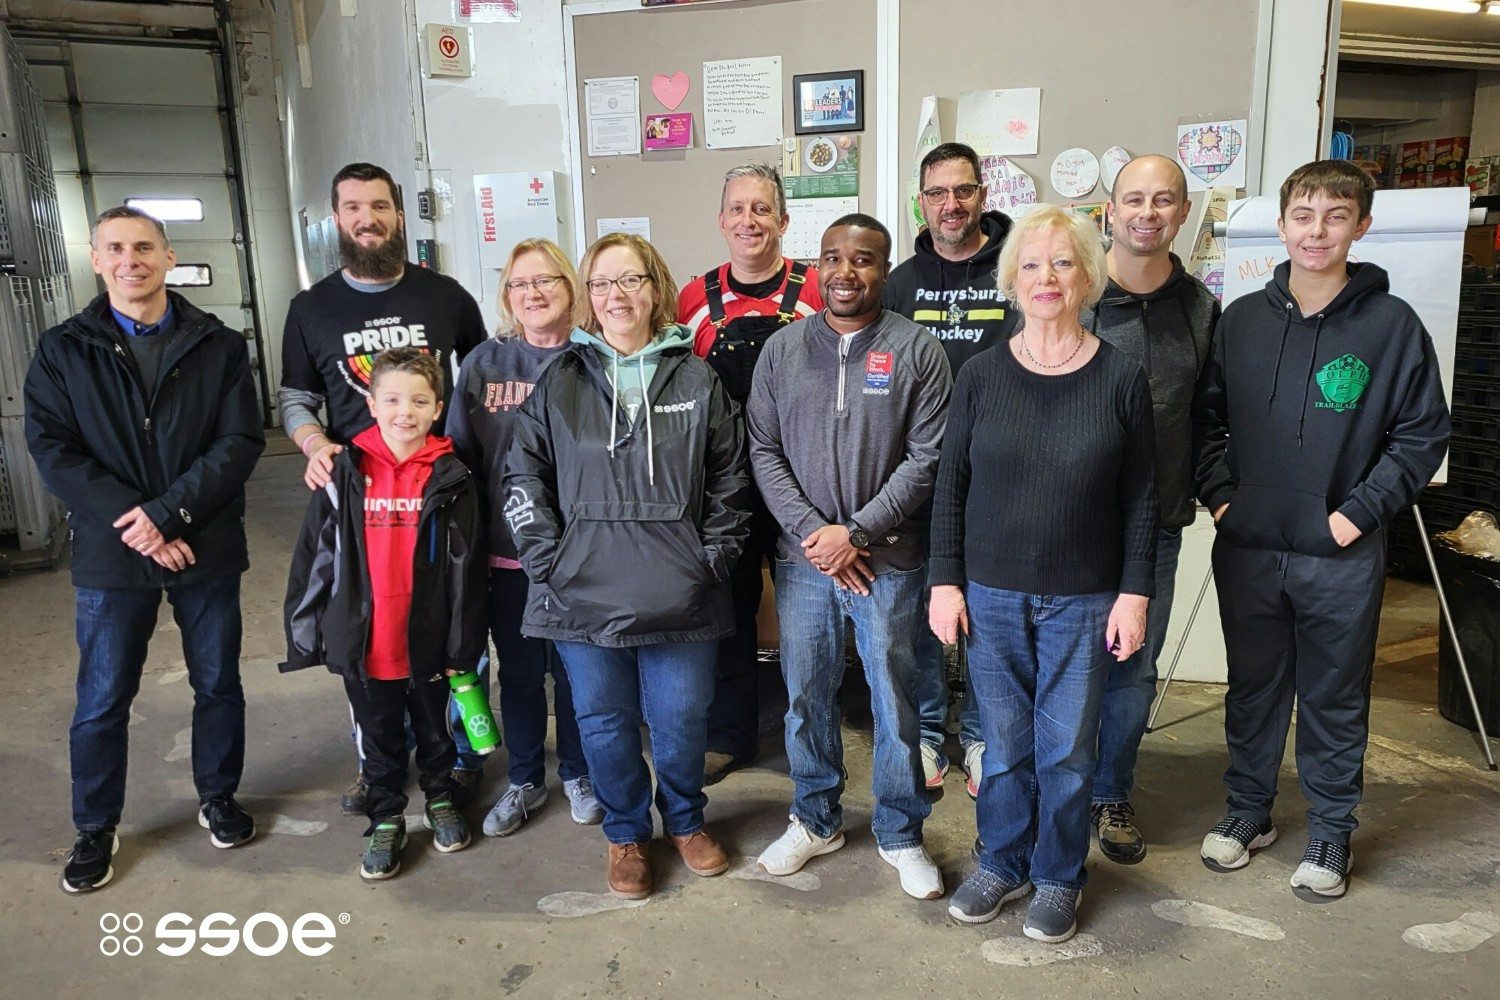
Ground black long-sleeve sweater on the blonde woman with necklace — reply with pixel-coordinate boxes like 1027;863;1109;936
929;343;1157;597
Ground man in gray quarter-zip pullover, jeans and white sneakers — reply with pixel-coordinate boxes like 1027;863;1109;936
746;213;953;900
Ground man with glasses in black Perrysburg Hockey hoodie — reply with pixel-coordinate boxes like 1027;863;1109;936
881;142;1016;798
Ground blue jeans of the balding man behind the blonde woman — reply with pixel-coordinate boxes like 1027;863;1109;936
1094;528;1182;802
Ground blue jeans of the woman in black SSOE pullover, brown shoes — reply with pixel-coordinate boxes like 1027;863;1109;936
557;639;719;844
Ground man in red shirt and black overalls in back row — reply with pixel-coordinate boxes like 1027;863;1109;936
677;163;824;784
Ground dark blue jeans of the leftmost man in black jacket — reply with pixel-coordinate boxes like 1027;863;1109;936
68;574;245;832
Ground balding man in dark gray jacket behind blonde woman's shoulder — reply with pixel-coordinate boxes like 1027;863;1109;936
1083;156;1220;865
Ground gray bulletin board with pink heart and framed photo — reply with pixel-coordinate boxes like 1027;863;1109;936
573;0;876;283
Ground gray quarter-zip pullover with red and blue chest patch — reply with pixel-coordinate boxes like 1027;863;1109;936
746;309;953;573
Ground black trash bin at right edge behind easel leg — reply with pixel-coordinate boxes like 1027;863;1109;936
1433;540;1500;736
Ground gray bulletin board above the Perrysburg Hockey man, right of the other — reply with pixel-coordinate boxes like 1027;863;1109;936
900;0;1271;256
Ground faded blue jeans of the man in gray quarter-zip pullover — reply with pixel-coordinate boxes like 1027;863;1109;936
776;559;932;850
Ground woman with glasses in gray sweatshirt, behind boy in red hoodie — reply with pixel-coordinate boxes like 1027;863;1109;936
449;240;605;837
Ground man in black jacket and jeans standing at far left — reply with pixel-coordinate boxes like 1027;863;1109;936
26;207;266;892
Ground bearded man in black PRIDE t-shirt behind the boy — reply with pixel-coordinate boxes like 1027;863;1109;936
278;163;488;816
